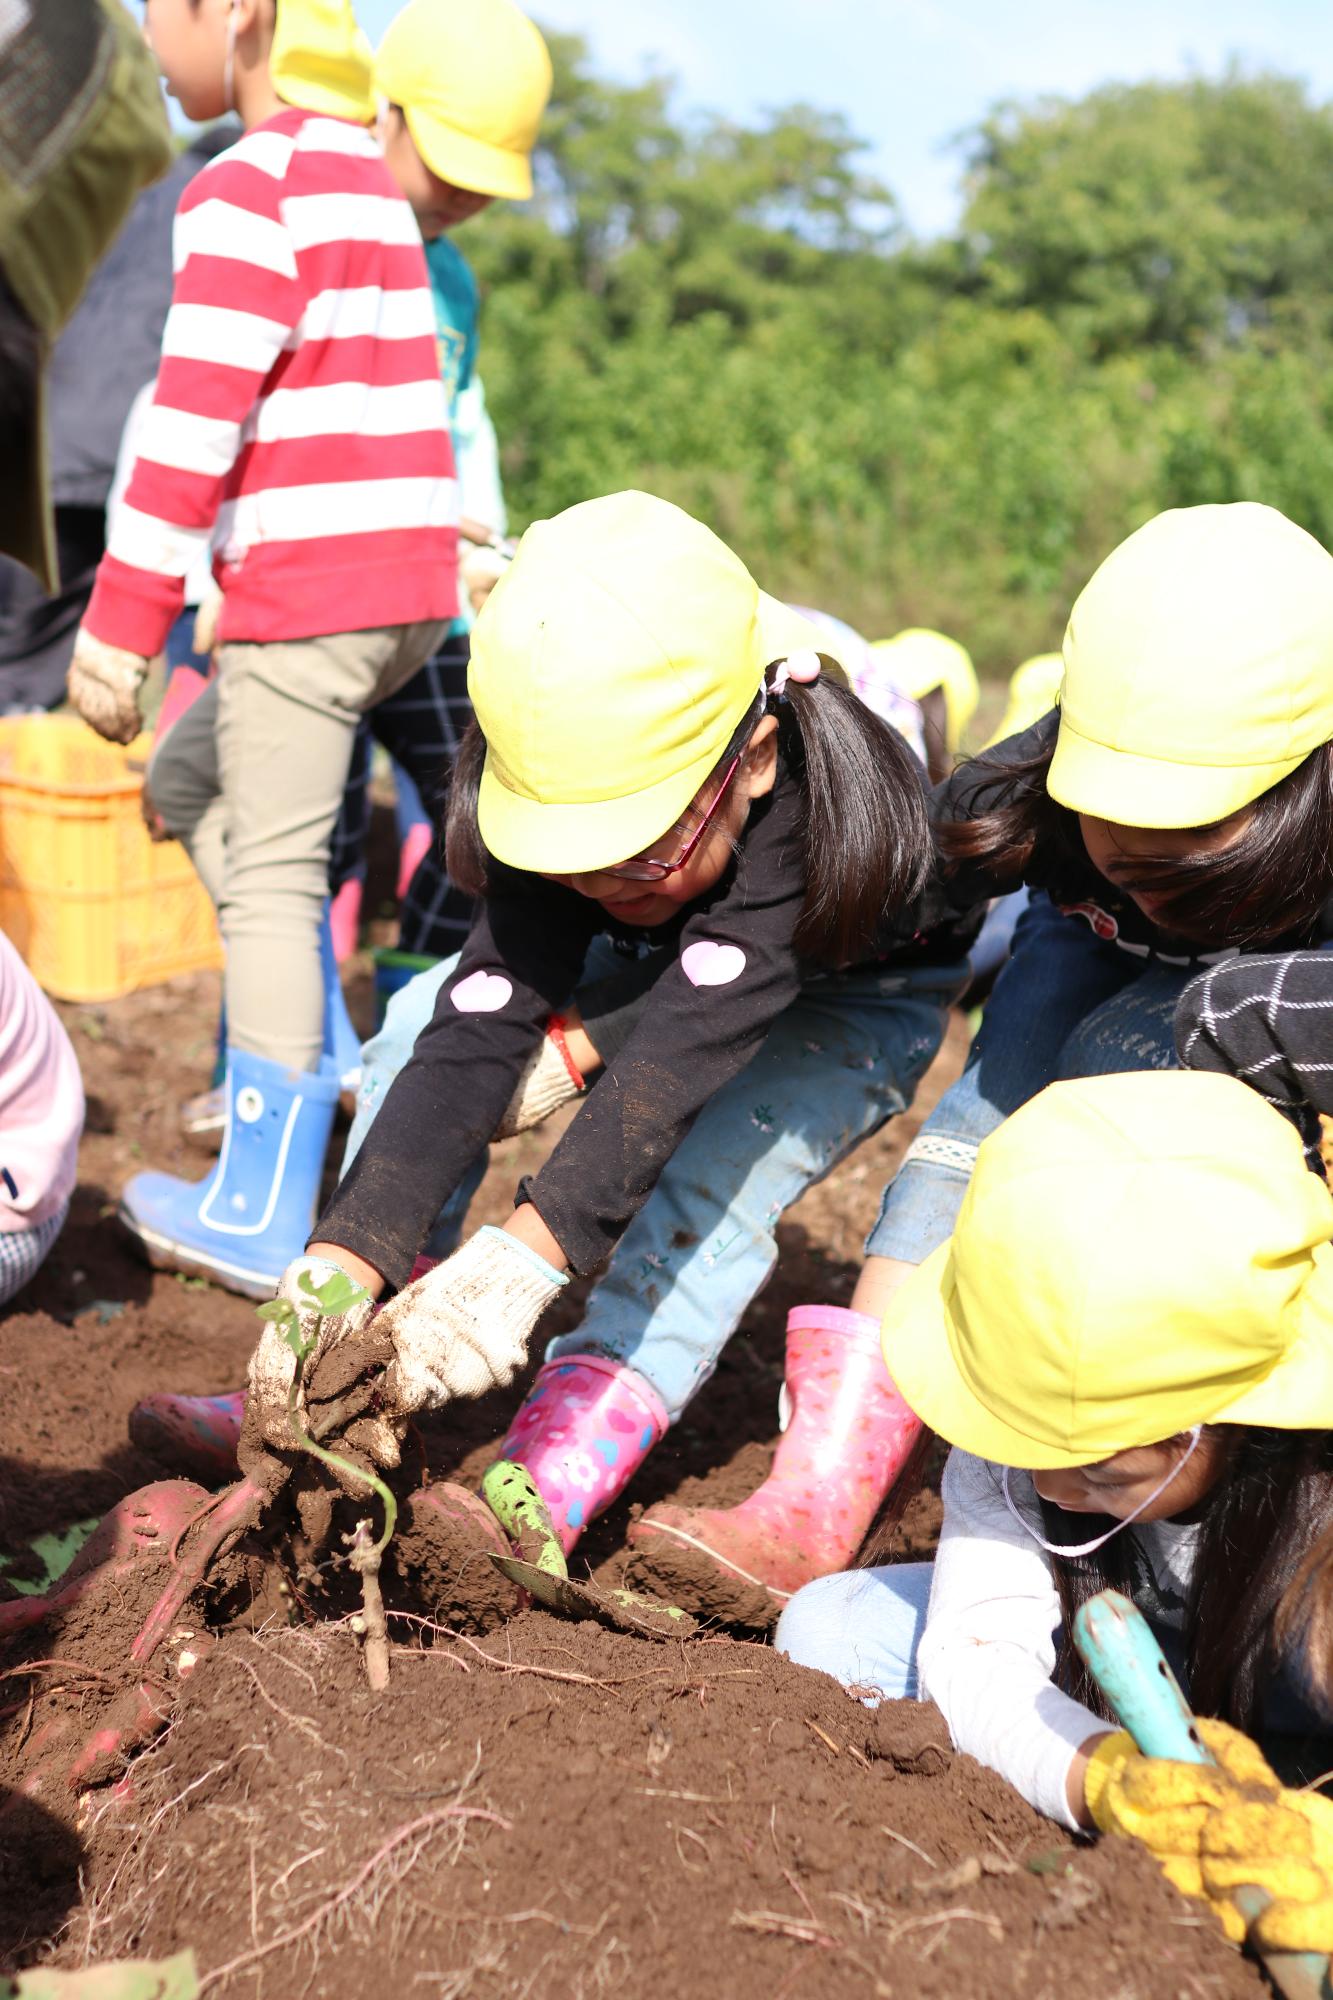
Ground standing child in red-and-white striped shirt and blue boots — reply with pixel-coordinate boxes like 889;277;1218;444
70;0;456;1296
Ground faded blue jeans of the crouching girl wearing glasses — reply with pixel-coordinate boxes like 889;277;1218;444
342;940;967;1422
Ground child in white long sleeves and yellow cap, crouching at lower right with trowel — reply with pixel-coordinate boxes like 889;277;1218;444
777;1072;1333;1888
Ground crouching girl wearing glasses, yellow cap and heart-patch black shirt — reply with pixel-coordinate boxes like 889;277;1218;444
145;494;965;1622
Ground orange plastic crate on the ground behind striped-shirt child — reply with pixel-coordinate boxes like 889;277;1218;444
0;716;222;1000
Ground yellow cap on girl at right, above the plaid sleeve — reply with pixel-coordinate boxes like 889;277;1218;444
1047;500;1333;826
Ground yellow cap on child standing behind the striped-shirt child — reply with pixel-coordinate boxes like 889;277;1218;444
374;0;550;202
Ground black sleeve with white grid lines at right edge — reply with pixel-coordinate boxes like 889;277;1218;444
1175;952;1333;1158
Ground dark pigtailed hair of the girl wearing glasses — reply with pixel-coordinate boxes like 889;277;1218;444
444;674;933;966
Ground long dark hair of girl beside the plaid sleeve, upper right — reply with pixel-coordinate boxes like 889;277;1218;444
935;728;1333;946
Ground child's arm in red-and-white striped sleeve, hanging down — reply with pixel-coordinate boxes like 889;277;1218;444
82;143;306;660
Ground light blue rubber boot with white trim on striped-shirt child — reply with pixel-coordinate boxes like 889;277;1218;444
120;1048;338;1298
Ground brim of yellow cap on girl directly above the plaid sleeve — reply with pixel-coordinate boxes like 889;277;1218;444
1047;712;1303;828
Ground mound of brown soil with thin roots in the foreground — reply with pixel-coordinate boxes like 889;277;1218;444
10;1612;1259;2000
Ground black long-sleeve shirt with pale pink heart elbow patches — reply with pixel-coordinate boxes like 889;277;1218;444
316;760;977;1286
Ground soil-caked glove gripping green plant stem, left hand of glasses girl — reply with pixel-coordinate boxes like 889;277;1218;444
238;1256;402;1498
